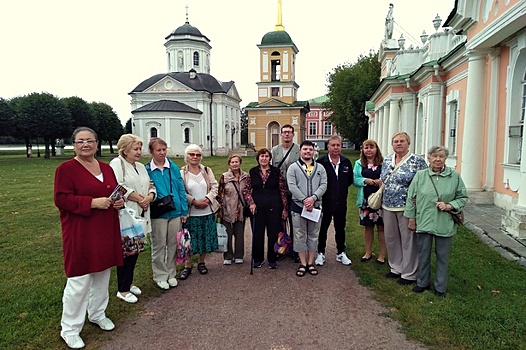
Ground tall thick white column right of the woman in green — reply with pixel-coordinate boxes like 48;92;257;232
461;51;486;191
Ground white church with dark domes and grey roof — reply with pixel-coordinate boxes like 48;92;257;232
129;13;241;157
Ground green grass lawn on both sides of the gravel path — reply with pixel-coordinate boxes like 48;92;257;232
0;152;526;349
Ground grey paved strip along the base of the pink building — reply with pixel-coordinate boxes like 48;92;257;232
464;205;526;267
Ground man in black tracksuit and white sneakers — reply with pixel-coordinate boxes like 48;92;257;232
315;135;353;266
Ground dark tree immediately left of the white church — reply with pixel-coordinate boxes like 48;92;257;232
90;102;123;156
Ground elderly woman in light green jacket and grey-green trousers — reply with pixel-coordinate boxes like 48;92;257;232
404;146;468;297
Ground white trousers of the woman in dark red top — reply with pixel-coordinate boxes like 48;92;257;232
60;269;111;336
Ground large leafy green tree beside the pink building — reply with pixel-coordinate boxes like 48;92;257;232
324;51;381;145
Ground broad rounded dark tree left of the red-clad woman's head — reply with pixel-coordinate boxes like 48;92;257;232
15;92;72;159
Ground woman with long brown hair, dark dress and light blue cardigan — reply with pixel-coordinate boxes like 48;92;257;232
353;140;386;264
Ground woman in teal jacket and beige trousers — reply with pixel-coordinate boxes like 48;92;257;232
146;137;188;289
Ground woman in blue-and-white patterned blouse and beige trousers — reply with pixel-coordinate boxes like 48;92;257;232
380;131;427;285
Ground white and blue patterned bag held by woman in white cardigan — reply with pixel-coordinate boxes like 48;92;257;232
119;207;145;257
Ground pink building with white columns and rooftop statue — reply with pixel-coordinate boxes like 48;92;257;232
365;0;526;238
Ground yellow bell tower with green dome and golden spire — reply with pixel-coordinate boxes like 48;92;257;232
245;0;310;149
